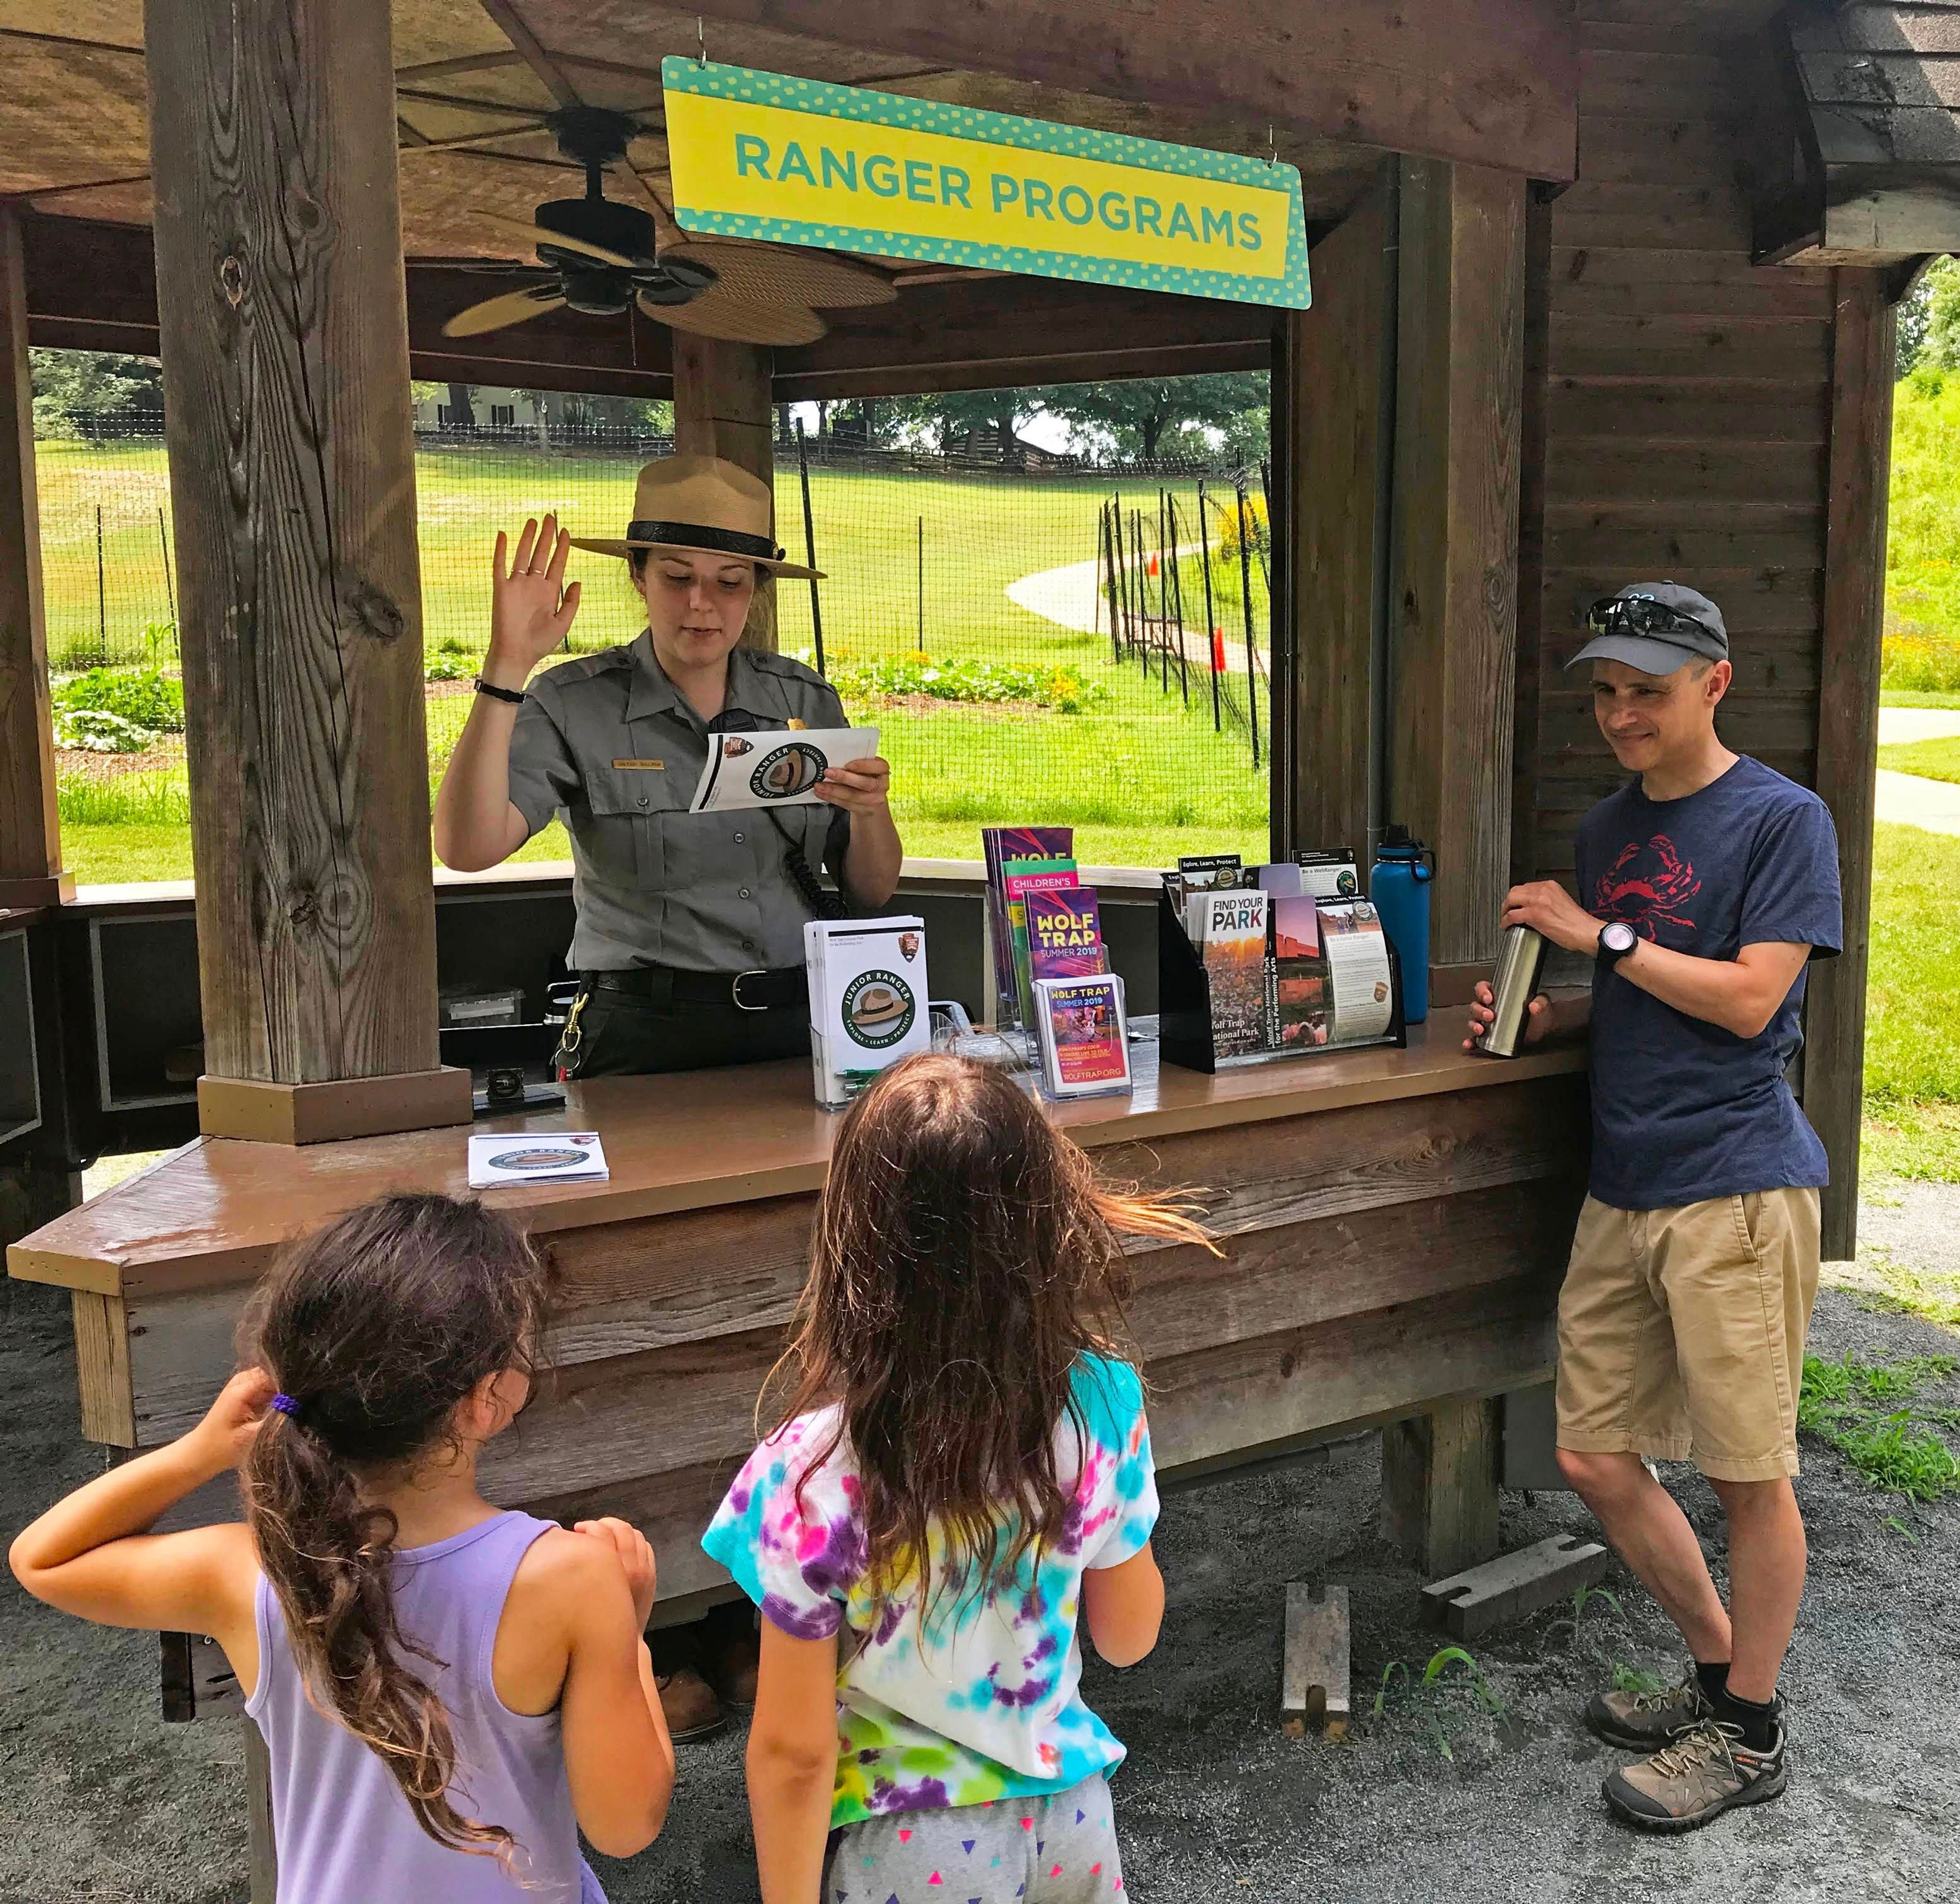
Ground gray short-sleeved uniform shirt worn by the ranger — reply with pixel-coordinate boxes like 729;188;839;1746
509;633;851;972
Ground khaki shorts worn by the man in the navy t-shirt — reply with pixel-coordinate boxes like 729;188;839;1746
1558;1189;1819;1481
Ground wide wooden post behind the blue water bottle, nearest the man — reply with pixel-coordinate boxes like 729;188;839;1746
1382;159;1527;1005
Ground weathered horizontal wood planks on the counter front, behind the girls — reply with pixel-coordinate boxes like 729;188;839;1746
107;1075;1586;1596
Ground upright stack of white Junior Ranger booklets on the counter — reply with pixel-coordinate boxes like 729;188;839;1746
803;913;933;1110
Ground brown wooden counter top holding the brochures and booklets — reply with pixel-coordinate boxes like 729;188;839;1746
8;1011;1586;1297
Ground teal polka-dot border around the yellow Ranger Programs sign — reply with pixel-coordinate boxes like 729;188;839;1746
660;55;1311;309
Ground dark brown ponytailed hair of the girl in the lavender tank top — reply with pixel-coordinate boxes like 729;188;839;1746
239;1197;547;1857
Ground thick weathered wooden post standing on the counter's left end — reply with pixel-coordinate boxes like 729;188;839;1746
145;0;471;1142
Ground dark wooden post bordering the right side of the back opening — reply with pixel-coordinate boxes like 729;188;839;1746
1274;176;1395;854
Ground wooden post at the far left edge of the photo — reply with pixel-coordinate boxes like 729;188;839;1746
0;204;75;907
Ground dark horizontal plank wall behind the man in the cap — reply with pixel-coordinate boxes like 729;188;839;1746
1525;0;1832;876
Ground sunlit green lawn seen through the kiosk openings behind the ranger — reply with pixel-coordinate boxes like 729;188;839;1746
37;442;1268;881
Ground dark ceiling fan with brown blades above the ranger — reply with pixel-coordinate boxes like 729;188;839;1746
443;106;898;345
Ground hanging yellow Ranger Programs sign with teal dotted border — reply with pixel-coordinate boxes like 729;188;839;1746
663;59;1309;308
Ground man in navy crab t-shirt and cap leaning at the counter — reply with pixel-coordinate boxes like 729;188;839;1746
1470;582;1843;1832
